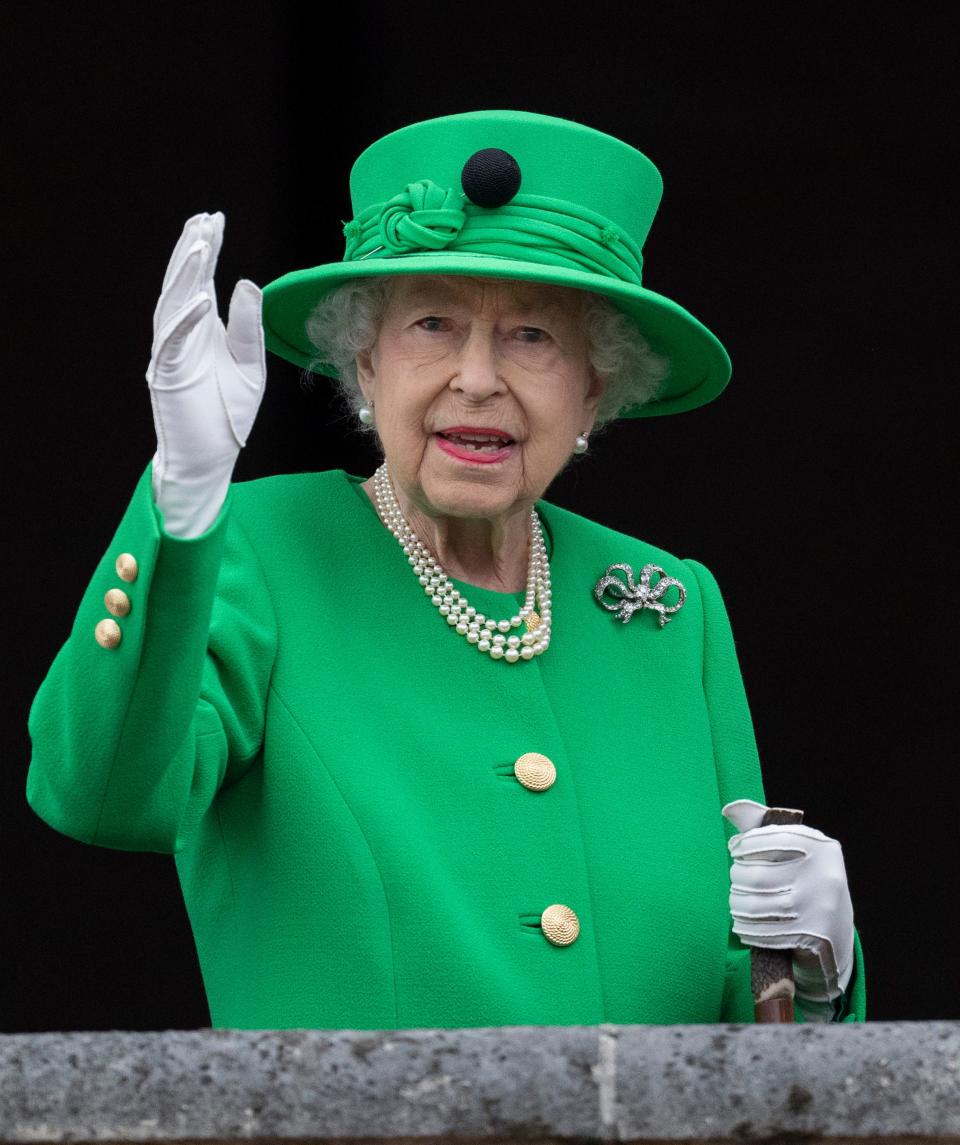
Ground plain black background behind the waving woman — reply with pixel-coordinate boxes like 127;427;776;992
0;0;960;1032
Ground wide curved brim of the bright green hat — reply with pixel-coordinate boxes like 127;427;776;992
263;251;731;418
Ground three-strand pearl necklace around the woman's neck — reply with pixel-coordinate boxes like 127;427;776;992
373;463;551;664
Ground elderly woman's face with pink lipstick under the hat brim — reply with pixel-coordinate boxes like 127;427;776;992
356;275;603;518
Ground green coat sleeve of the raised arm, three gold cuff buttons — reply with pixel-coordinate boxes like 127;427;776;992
26;465;276;854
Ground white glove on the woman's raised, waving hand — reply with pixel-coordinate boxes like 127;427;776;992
147;211;267;537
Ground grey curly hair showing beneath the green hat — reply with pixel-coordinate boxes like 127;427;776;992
305;275;669;433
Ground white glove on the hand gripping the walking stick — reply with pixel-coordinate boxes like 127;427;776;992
722;799;853;1003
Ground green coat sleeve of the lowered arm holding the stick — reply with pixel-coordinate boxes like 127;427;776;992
684;559;866;1022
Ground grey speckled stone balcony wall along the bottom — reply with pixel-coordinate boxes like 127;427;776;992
0;1022;960;1145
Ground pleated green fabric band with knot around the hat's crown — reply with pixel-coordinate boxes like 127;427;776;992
344;179;643;286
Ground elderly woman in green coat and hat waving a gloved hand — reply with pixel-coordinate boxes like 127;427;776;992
26;111;864;1028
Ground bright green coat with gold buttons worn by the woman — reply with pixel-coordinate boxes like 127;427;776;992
26;466;864;1029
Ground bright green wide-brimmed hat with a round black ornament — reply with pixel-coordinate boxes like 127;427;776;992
263;111;730;417
